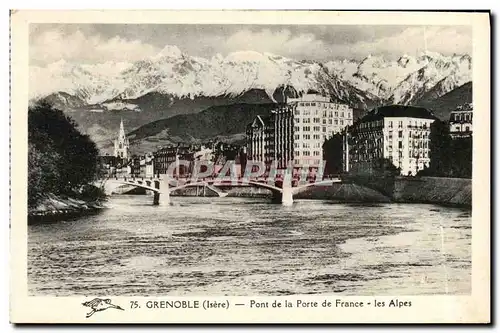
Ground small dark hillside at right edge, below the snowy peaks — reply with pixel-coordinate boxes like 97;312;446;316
417;82;472;120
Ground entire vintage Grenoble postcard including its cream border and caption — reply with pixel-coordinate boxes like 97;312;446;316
10;10;491;323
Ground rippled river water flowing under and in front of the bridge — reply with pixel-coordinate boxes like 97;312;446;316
28;196;471;296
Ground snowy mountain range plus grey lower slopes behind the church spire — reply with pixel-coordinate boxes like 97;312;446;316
29;46;472;147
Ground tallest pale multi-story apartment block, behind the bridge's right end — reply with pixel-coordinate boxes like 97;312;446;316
247;93;353;169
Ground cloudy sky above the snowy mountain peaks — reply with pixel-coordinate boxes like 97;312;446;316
30;24;472;65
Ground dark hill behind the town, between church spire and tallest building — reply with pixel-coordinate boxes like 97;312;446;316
123;103;276;154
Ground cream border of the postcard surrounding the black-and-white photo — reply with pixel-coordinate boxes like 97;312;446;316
10;10;491;323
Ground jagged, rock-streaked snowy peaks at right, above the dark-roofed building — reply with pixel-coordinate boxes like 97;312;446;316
326;52;472;104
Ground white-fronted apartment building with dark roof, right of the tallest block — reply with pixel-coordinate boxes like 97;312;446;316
344;105;436;175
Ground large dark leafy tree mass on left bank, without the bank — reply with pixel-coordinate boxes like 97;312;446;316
28;102;98;206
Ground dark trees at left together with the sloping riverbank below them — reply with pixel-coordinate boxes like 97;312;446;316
28;102;105;222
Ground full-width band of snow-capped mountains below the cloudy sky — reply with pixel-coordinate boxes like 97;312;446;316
29;46;472;107
